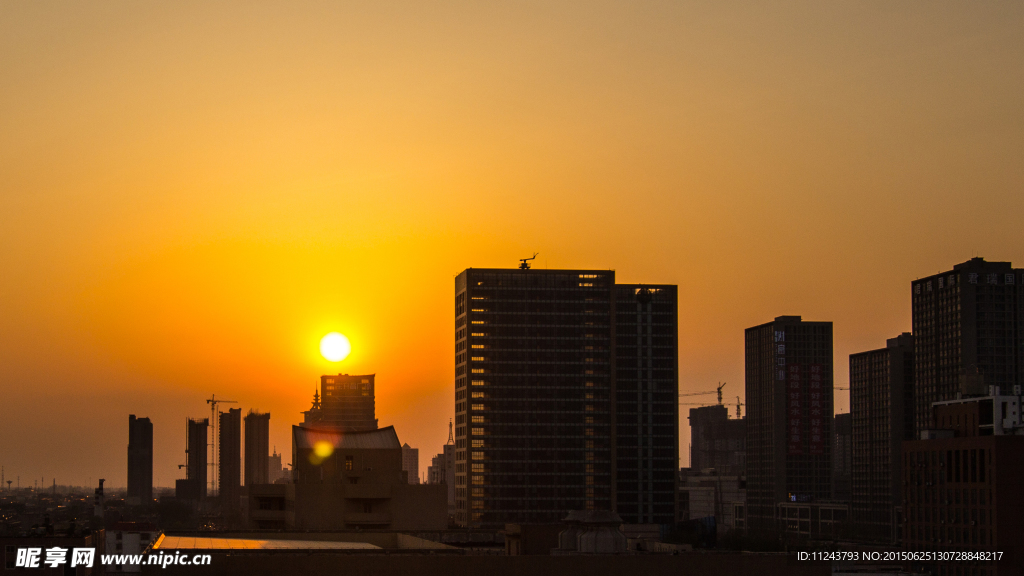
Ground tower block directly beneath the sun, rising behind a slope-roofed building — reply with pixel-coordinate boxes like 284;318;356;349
317;374;377;431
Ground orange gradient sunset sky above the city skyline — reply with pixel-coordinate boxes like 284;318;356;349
0;0;1024;486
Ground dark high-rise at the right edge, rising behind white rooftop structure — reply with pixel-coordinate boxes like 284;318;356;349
911;258;1024;436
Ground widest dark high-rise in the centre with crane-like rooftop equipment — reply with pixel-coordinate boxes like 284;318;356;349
455;268;678;527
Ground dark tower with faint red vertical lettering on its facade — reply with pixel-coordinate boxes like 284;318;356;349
745;316;834;530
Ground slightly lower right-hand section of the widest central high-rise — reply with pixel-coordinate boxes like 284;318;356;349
612;284;679;524
